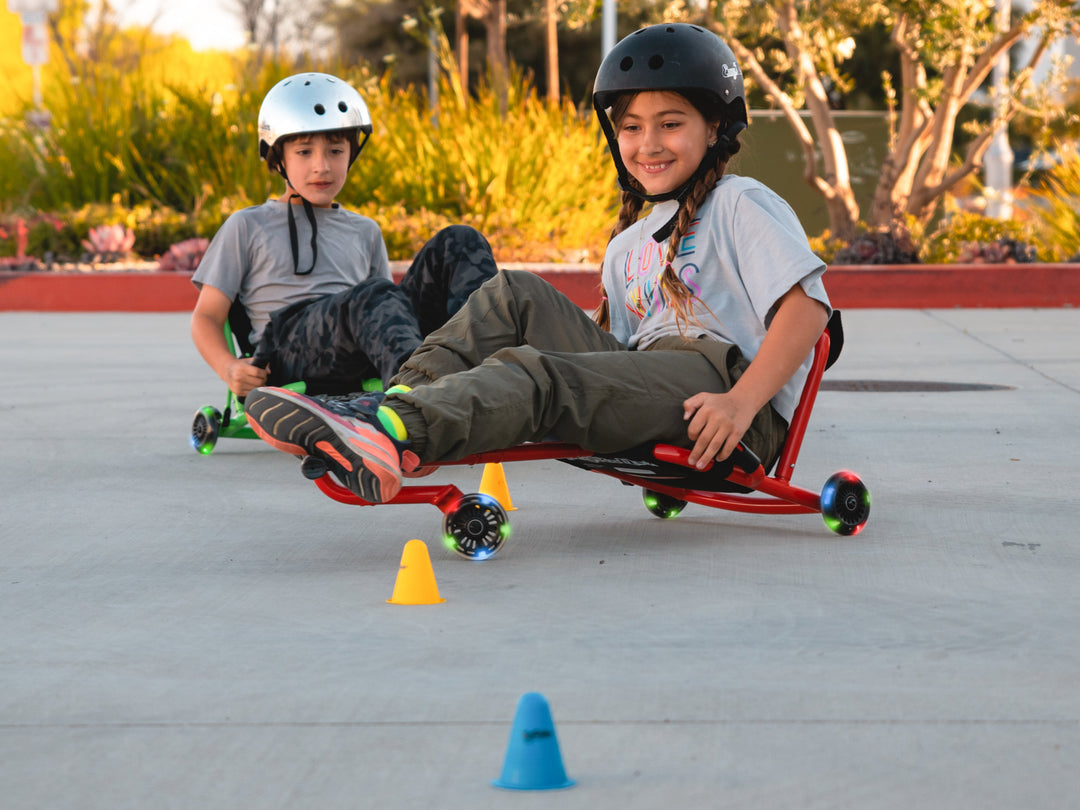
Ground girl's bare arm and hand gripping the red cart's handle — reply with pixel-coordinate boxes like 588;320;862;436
683;284;828;468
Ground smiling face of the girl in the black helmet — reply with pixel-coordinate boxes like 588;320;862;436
616;90;717;194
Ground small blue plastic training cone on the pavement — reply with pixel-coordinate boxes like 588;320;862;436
491;692;575;791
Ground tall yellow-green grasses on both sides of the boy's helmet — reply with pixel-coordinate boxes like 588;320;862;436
0;25;618;260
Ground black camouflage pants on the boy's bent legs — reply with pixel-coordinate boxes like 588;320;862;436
256;225;498;394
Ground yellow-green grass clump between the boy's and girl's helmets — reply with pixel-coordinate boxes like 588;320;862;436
342;47;618;260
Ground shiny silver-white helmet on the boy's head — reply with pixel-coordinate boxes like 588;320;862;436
259;73;372;166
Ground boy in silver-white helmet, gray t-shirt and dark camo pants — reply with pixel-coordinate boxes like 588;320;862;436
191;73;497;397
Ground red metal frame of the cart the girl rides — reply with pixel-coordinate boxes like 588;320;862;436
315;332;829;514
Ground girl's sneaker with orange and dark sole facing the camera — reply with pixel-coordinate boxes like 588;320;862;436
244;388;411;503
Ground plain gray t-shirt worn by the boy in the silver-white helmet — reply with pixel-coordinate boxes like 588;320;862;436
191;200;391;343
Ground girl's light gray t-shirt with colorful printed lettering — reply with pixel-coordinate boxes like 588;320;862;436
604;175;832;421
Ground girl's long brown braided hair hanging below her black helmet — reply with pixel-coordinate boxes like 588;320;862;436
593;91;740;334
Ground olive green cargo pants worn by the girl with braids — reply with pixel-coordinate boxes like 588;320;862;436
383;270;787;469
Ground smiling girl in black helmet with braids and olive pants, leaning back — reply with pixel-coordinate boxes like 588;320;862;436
247;24;831;502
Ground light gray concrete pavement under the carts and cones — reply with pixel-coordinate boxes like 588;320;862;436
0;309;1080;810
